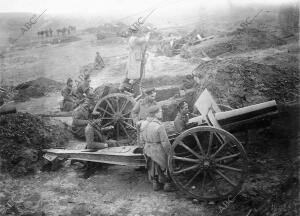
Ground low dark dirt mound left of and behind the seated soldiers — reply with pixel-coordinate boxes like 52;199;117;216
13;77;63;101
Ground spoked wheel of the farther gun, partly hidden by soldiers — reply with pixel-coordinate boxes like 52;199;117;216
94;93;136;141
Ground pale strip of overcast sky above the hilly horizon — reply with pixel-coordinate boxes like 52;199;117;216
0;0;297;17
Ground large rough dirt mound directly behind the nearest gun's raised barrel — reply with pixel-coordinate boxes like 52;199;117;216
194;54;300;108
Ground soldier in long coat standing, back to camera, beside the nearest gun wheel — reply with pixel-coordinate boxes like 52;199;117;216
140;106;175;191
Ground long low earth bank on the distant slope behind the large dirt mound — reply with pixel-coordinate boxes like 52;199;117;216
190;28;286;58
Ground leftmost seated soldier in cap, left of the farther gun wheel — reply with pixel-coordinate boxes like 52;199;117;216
61;78;76;112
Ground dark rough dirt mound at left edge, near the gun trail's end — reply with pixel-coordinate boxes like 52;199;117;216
0;113;70;176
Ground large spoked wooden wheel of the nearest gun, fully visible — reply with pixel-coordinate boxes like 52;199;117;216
168;126;248;200
